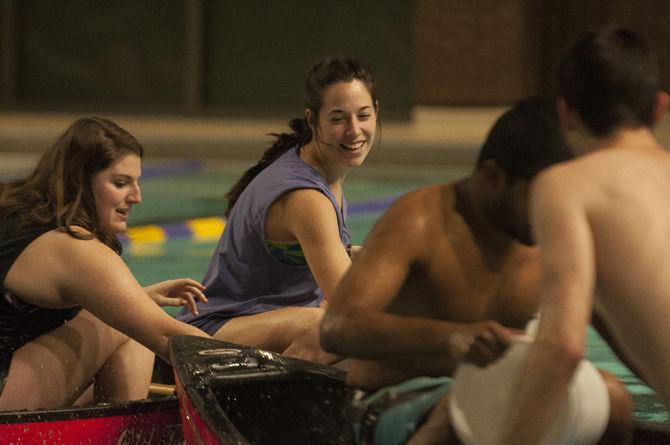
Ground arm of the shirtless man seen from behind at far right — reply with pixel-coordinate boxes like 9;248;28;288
500;166;595;444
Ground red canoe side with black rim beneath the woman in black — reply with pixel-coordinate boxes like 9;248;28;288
0;396;184;445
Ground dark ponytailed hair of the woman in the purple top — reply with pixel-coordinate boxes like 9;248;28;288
225;56;378;217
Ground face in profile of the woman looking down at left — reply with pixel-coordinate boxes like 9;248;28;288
91;153;142;233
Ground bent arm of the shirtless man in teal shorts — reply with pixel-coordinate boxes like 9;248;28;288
321;191;484;360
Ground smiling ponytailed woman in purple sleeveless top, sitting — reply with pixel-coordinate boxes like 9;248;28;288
184;57;379;363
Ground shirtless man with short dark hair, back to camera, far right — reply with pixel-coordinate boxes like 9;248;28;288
498;27;670;444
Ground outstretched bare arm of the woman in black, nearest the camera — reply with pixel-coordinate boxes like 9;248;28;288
5;230;207;359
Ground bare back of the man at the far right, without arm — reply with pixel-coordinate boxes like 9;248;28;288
548;139;670;406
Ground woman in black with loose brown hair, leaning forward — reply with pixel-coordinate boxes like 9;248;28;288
0;118;206;410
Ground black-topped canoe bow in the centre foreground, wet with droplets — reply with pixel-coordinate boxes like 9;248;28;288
170;336;350;445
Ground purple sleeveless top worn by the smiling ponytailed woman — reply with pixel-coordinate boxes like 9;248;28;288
177;148;350;334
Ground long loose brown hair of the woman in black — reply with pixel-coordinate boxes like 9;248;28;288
0;117;144;253
